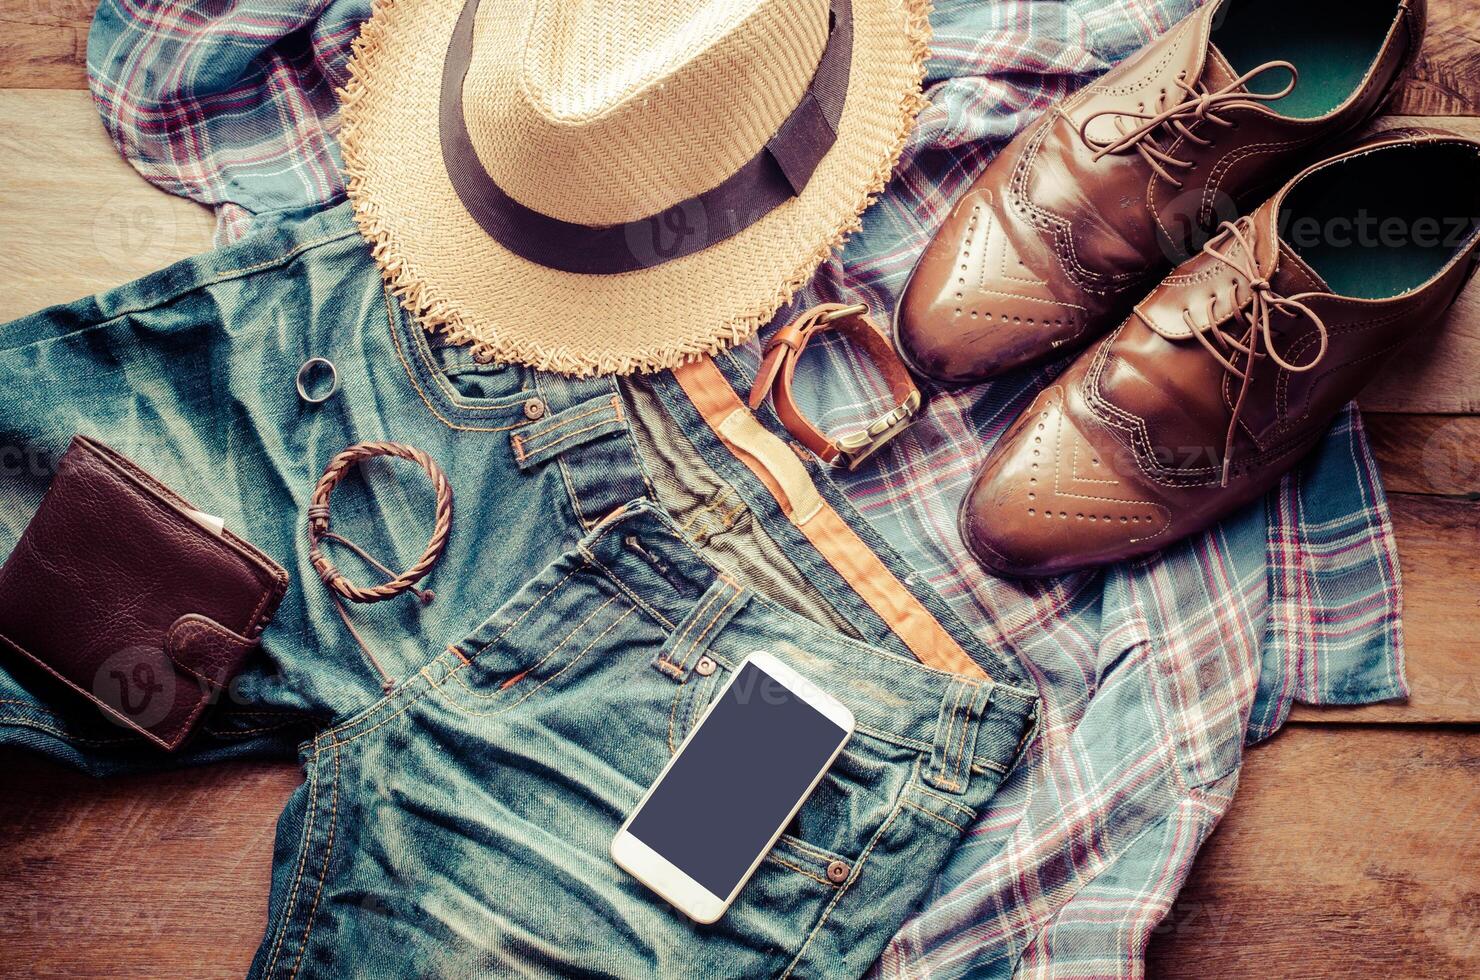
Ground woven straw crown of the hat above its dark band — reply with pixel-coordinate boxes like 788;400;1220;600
463;0;829;226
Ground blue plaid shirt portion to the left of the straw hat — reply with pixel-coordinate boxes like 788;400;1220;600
87;0;370;244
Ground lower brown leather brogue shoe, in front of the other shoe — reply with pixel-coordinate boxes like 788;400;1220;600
961;130;1480;576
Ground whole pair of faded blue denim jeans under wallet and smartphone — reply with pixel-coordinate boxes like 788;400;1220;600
0;207;1036;977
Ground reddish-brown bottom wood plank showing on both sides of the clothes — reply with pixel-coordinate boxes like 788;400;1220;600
0;727;1480;980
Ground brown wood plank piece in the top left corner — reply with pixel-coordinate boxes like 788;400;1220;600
0;0;98;89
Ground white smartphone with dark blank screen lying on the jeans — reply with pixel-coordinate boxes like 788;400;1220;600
611;653;854;924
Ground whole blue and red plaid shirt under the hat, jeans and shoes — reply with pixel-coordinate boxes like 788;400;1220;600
87;0;1407;977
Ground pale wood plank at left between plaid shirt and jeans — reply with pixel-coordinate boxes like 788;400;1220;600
0;90;215;323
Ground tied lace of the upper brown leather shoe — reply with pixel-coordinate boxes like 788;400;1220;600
1079;61;1299;189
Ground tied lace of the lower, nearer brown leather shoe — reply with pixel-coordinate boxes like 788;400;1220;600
1183;218;1329;487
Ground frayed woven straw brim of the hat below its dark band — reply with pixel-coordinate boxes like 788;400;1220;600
340;0;929;376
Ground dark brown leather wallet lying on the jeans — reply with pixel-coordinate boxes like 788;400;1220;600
0;435;289;751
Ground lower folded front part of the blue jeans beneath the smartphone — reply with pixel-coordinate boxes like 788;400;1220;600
274;505;1018;977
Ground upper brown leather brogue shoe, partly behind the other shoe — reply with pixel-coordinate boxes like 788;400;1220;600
894;0;1425;382
